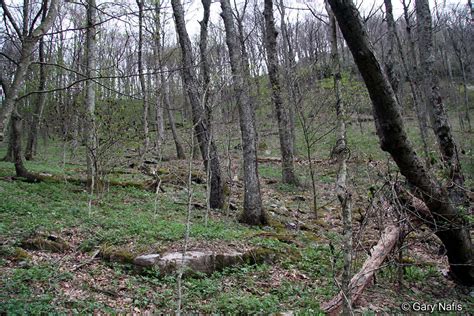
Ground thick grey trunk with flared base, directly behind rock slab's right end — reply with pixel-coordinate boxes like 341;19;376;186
220;0;267;225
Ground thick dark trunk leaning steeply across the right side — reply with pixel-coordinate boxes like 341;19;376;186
328;0;474;285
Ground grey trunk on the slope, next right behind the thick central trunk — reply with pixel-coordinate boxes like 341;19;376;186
263;0;298;185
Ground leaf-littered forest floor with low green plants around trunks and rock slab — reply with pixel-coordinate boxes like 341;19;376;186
0;122;474;315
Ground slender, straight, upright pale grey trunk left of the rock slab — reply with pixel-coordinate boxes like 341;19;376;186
85;0;98;191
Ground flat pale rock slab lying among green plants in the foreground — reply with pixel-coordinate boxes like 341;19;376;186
133;249;274;275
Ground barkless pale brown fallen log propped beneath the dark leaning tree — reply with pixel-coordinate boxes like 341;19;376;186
321;224;401;315
